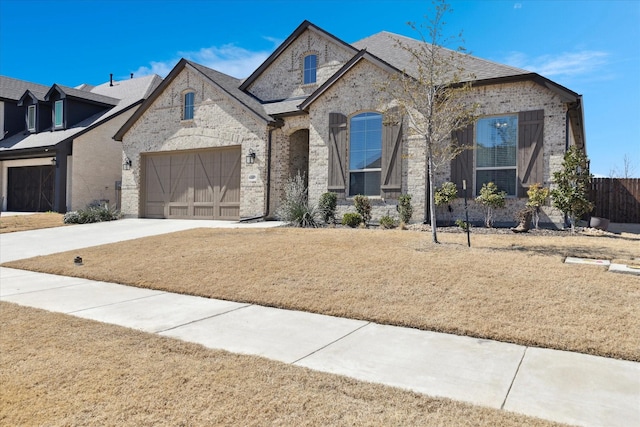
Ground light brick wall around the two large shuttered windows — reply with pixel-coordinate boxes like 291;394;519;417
302;61;566;229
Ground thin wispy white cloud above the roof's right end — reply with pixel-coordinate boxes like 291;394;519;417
506;50;609;77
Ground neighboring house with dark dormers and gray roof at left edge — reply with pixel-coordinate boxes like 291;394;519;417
0;75;162;212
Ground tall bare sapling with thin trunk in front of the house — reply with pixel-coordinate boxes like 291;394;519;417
381;0;477;243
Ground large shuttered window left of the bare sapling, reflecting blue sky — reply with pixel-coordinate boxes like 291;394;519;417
349;113;382;196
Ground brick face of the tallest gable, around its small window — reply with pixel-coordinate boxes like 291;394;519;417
249;28;356;101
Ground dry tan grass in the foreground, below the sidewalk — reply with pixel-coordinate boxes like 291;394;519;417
0;303;557;427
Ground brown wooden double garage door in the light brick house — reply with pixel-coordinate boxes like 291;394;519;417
143;147;240;220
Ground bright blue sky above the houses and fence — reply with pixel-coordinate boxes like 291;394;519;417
0;0;640;177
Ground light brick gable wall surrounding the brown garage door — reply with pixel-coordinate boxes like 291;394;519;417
122;65;268;218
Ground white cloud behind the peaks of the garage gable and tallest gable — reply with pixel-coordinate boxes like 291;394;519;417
134;40;275;78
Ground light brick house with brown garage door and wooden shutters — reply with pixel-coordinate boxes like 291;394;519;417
115;21;585;224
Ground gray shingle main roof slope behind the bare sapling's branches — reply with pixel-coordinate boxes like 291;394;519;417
353;31;531;80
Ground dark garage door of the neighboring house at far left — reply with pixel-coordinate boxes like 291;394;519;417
7;165;55;212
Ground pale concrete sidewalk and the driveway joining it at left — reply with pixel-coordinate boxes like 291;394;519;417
0;220;640;427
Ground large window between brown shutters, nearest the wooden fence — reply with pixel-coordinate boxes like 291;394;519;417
476;115;518;196
